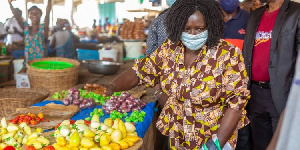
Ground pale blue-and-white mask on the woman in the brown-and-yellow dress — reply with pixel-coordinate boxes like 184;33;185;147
181;30;208;50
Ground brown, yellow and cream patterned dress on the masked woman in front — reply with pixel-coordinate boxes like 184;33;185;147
133;40;250;149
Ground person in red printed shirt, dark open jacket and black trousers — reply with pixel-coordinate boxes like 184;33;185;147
243;0;300;150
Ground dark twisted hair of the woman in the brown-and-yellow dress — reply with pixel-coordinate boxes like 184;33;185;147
165;0;224;47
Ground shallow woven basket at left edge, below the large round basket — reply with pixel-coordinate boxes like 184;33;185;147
0;88;49;118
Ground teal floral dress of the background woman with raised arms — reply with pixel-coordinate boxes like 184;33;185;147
24;22;47;66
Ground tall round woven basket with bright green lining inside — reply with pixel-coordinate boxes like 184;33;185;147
26;57;80;94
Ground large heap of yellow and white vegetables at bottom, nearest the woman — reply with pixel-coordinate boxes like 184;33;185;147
52;113;140;150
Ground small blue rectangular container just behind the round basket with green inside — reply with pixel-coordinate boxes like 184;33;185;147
77;49;99;60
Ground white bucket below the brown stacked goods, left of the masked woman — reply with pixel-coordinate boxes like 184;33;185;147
124;42;143;58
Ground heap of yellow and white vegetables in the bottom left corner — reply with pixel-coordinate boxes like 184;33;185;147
0;118;50;150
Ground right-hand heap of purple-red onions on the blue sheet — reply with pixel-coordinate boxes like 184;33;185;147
102;92;146;114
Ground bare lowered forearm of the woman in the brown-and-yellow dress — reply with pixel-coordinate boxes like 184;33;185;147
217;108;242;147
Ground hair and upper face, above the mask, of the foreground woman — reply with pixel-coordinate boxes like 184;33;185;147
165;0;224;47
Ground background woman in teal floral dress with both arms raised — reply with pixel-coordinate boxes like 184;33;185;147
8;0;52;64
